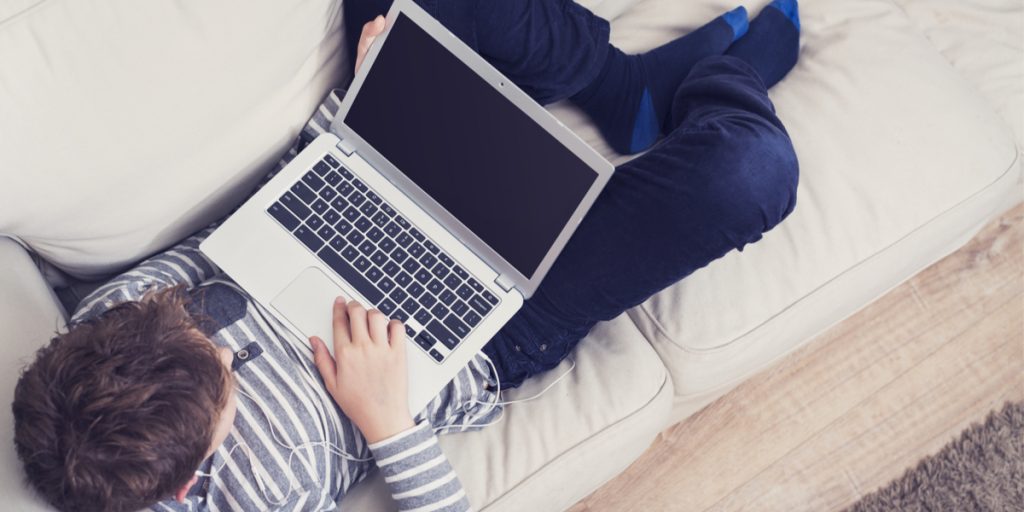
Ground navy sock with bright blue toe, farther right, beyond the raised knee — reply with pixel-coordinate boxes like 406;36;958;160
725;0;800;88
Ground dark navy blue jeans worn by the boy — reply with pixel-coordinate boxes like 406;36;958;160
345;0;799;387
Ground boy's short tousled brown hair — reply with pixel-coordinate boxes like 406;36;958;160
12;286;229;511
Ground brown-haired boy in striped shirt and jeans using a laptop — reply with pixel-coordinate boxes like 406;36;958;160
13;0;799;510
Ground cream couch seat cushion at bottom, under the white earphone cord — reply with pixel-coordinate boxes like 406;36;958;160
341;314;672;512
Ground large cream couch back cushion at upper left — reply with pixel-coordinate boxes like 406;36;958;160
0;0;350;279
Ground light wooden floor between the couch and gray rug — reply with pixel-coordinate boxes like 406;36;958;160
571;205;1024;512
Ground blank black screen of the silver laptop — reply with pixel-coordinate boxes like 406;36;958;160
344;13;598;278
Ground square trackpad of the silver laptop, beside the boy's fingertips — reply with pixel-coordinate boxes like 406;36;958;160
270;266;348;355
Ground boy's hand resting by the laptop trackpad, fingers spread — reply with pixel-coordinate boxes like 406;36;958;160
309;297;415;442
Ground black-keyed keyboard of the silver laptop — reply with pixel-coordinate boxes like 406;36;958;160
266;155;499;362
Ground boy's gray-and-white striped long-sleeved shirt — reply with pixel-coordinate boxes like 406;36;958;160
69;93;501;511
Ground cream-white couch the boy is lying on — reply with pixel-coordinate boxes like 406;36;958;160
0;0;1024;511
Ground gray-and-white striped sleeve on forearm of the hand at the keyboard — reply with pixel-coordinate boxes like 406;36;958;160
370;421;472;512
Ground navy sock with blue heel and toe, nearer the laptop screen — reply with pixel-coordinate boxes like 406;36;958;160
571;7;748;154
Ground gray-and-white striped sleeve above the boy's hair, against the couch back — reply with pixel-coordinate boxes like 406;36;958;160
69;222;220;325
